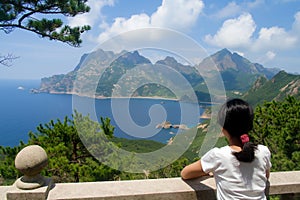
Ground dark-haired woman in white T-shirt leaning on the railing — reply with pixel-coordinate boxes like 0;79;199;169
181;99;271;200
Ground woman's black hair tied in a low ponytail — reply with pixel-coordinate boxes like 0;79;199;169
218;99;257;162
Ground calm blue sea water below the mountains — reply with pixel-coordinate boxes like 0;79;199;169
0;80;204;147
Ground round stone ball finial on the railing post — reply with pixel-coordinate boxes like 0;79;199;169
15;145;48;189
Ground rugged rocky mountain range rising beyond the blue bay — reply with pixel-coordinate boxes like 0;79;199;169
39;49;300;103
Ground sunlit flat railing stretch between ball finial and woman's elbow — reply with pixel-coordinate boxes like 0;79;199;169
48;178;196;200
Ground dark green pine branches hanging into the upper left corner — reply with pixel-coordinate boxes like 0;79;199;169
0;0;90;47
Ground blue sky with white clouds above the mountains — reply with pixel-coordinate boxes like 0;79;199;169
0;0;300;79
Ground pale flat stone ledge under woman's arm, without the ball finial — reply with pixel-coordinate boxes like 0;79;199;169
0;171;300;200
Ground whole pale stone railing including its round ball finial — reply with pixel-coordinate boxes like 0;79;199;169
0;146;300;200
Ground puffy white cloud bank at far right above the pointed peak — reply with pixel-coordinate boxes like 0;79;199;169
205;12;300;51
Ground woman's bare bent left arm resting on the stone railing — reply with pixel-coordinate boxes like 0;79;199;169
181;160;208;179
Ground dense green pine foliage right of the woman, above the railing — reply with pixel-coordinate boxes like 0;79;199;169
251;96;300;171
